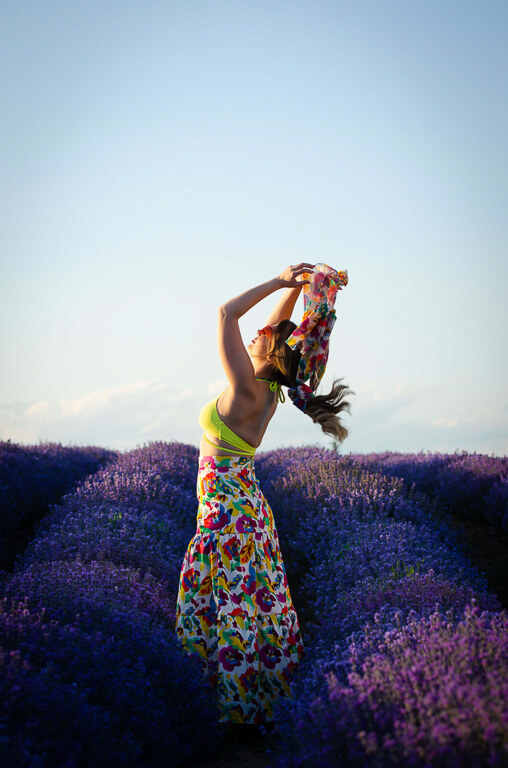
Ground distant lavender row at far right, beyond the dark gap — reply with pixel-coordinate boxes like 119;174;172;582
347;451;508;531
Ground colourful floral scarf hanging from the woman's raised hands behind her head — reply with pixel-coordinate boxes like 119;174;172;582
286;264;348;411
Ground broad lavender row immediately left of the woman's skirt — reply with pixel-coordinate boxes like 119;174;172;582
0;443;220;768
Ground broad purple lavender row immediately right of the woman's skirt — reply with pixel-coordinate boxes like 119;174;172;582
257;448;508;768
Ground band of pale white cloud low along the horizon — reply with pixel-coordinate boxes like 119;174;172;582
0;379;508;455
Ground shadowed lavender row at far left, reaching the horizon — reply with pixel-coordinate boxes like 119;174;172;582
0;440;118;567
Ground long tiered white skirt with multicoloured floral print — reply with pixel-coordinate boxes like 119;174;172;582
176;456;304;723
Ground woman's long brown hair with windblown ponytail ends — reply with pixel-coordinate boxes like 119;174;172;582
267;320;355;443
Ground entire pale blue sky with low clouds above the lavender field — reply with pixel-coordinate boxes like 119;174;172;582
0;0;508;454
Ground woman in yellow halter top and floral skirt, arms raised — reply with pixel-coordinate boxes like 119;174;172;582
176;263;349;724
